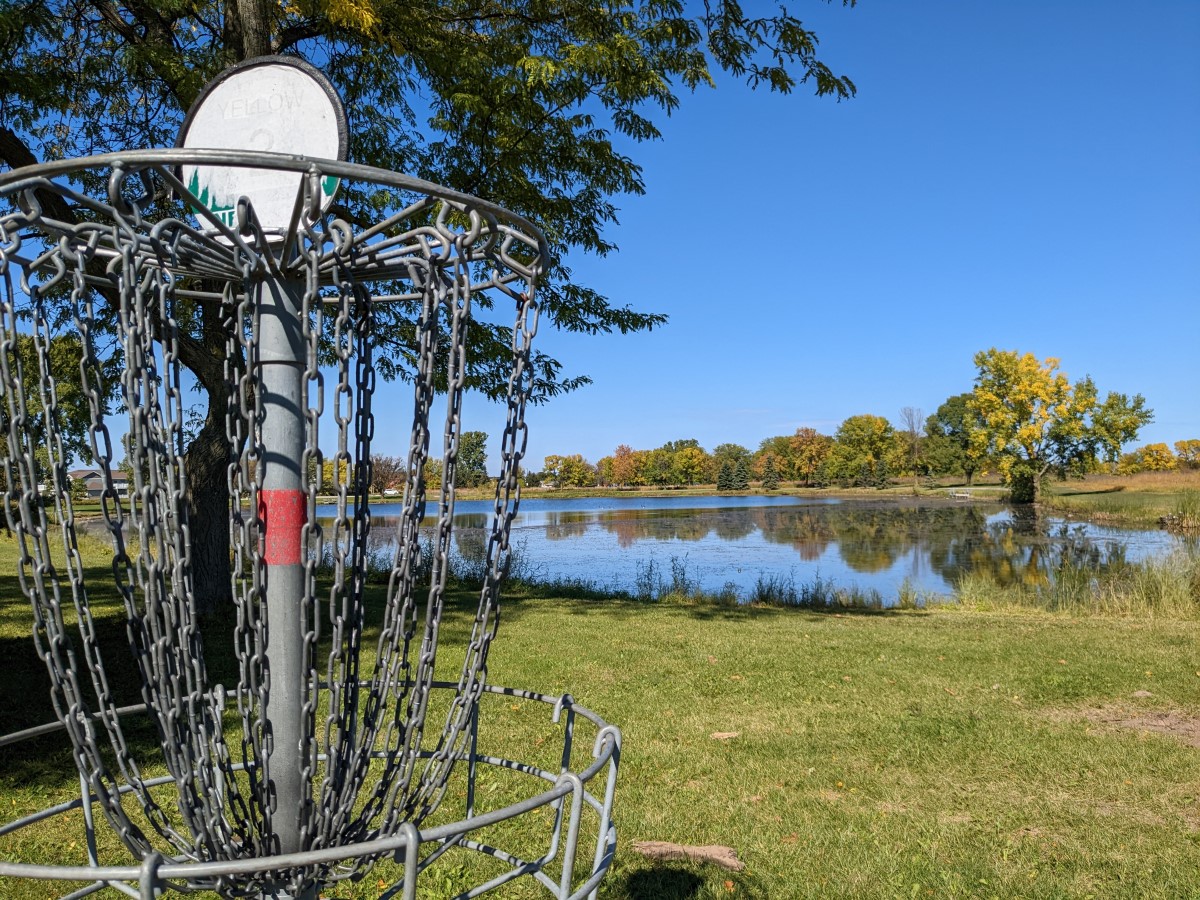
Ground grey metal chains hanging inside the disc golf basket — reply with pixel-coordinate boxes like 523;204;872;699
0;154;541;896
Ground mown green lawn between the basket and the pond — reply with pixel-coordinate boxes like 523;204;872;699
0;541;1200;900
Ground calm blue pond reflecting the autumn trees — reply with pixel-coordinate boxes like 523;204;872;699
318;497;1180;602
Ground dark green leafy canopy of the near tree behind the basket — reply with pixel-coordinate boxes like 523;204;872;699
0;0;854;398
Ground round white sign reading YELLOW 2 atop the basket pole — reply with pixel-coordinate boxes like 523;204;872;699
178;56;346;234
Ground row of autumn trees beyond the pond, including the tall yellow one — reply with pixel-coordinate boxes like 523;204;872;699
526;348;1180;502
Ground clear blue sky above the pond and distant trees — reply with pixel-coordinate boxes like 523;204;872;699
380;0;1200;470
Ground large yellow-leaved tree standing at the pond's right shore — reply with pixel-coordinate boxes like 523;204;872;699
967;347;1153;503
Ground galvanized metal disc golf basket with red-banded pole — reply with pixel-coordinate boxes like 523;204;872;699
0;60;620;899
